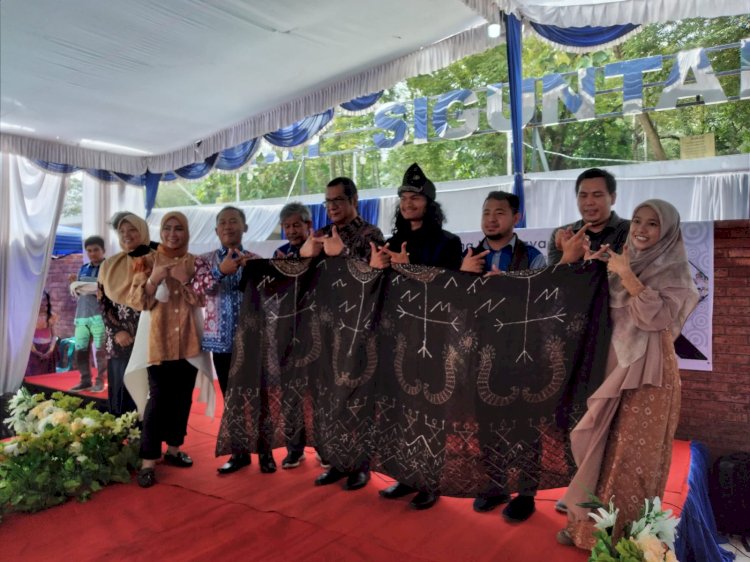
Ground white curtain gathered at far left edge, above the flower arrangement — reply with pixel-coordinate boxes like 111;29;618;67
0;153;67;393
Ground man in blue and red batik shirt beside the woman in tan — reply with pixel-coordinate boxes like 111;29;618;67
193;206;268;474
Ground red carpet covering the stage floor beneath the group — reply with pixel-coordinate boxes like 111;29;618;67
0;376;690;562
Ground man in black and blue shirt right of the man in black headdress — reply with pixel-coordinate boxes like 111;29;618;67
461;191;546;522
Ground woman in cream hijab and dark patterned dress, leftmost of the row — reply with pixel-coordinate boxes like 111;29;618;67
97;212;153;416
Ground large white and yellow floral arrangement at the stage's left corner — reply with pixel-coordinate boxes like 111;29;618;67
0;388;140;518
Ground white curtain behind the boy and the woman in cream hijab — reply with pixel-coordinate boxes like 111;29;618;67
81;174;144;256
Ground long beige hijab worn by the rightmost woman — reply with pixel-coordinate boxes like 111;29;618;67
609;199;698;367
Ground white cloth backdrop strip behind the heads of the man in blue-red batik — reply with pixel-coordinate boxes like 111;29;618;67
148;203;283;254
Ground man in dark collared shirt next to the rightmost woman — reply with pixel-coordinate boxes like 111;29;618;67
547;168;630;265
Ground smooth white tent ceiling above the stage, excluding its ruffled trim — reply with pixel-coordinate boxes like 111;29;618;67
0;0;486;171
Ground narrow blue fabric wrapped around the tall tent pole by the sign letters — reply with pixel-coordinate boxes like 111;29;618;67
503;10;526;228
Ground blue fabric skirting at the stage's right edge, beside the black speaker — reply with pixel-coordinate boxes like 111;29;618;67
674;441;734;562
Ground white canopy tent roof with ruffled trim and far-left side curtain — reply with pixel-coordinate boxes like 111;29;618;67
0;0;748;392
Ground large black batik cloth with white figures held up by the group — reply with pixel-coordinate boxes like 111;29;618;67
217;258;609;497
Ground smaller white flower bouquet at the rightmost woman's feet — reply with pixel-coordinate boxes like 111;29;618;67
581;497;680;562
